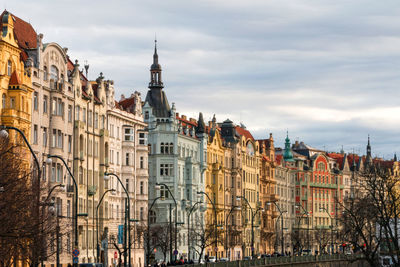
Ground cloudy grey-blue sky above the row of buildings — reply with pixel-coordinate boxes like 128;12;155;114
3;0;400;159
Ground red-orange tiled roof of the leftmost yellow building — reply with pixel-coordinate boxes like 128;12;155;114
0;10;37;49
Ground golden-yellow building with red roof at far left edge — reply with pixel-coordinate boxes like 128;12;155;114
0;11;36;141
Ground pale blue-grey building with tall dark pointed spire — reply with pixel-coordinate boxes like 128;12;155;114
143;43;207;261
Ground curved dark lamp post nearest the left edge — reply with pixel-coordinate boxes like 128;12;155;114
0;125;42;266
